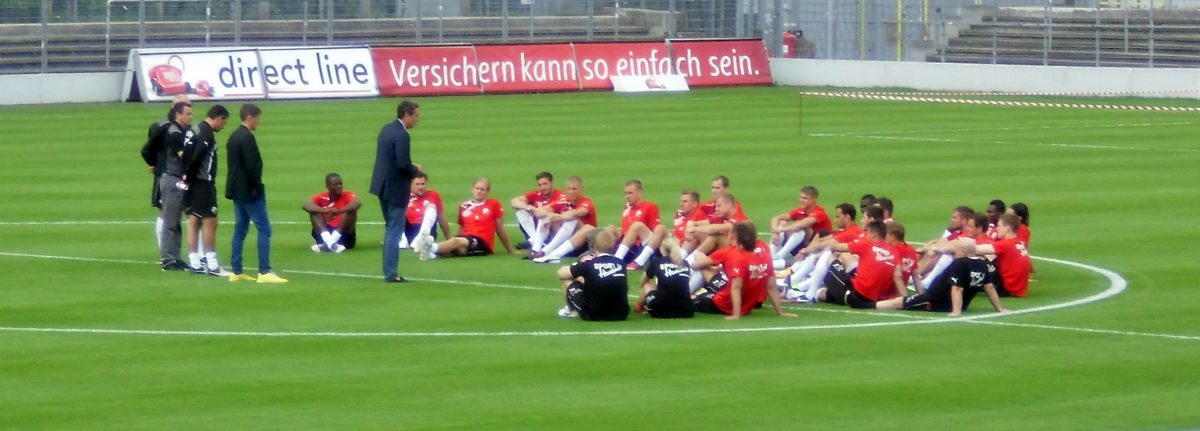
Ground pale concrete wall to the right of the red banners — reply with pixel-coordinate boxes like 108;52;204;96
770;59;1200;98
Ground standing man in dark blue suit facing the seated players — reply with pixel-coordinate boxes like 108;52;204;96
371;100;422;283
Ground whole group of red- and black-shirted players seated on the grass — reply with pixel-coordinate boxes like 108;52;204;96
305;172;1031;321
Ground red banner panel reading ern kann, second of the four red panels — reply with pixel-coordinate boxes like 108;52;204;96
475;43;580;92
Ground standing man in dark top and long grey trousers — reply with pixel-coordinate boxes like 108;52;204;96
158;102;194;271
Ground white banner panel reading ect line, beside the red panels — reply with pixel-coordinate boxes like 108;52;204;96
258;47;379;98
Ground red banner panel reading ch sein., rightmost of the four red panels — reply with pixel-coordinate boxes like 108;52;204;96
670;40;774;86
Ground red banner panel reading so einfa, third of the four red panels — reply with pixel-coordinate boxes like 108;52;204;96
575;42;674;90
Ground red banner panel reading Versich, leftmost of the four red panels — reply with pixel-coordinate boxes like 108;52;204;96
371;46;480;96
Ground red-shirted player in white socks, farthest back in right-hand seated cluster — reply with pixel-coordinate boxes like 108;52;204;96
770;186;833;269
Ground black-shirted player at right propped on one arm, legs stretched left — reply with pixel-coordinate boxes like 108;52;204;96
876;237;1008;317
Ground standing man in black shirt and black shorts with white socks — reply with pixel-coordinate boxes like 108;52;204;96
184;104;232;276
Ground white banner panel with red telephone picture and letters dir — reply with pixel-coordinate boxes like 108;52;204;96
130;48;265;102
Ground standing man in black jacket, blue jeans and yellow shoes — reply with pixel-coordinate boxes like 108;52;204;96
226;103;287;283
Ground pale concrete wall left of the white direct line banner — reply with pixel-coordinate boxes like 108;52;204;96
0;72;125;104
